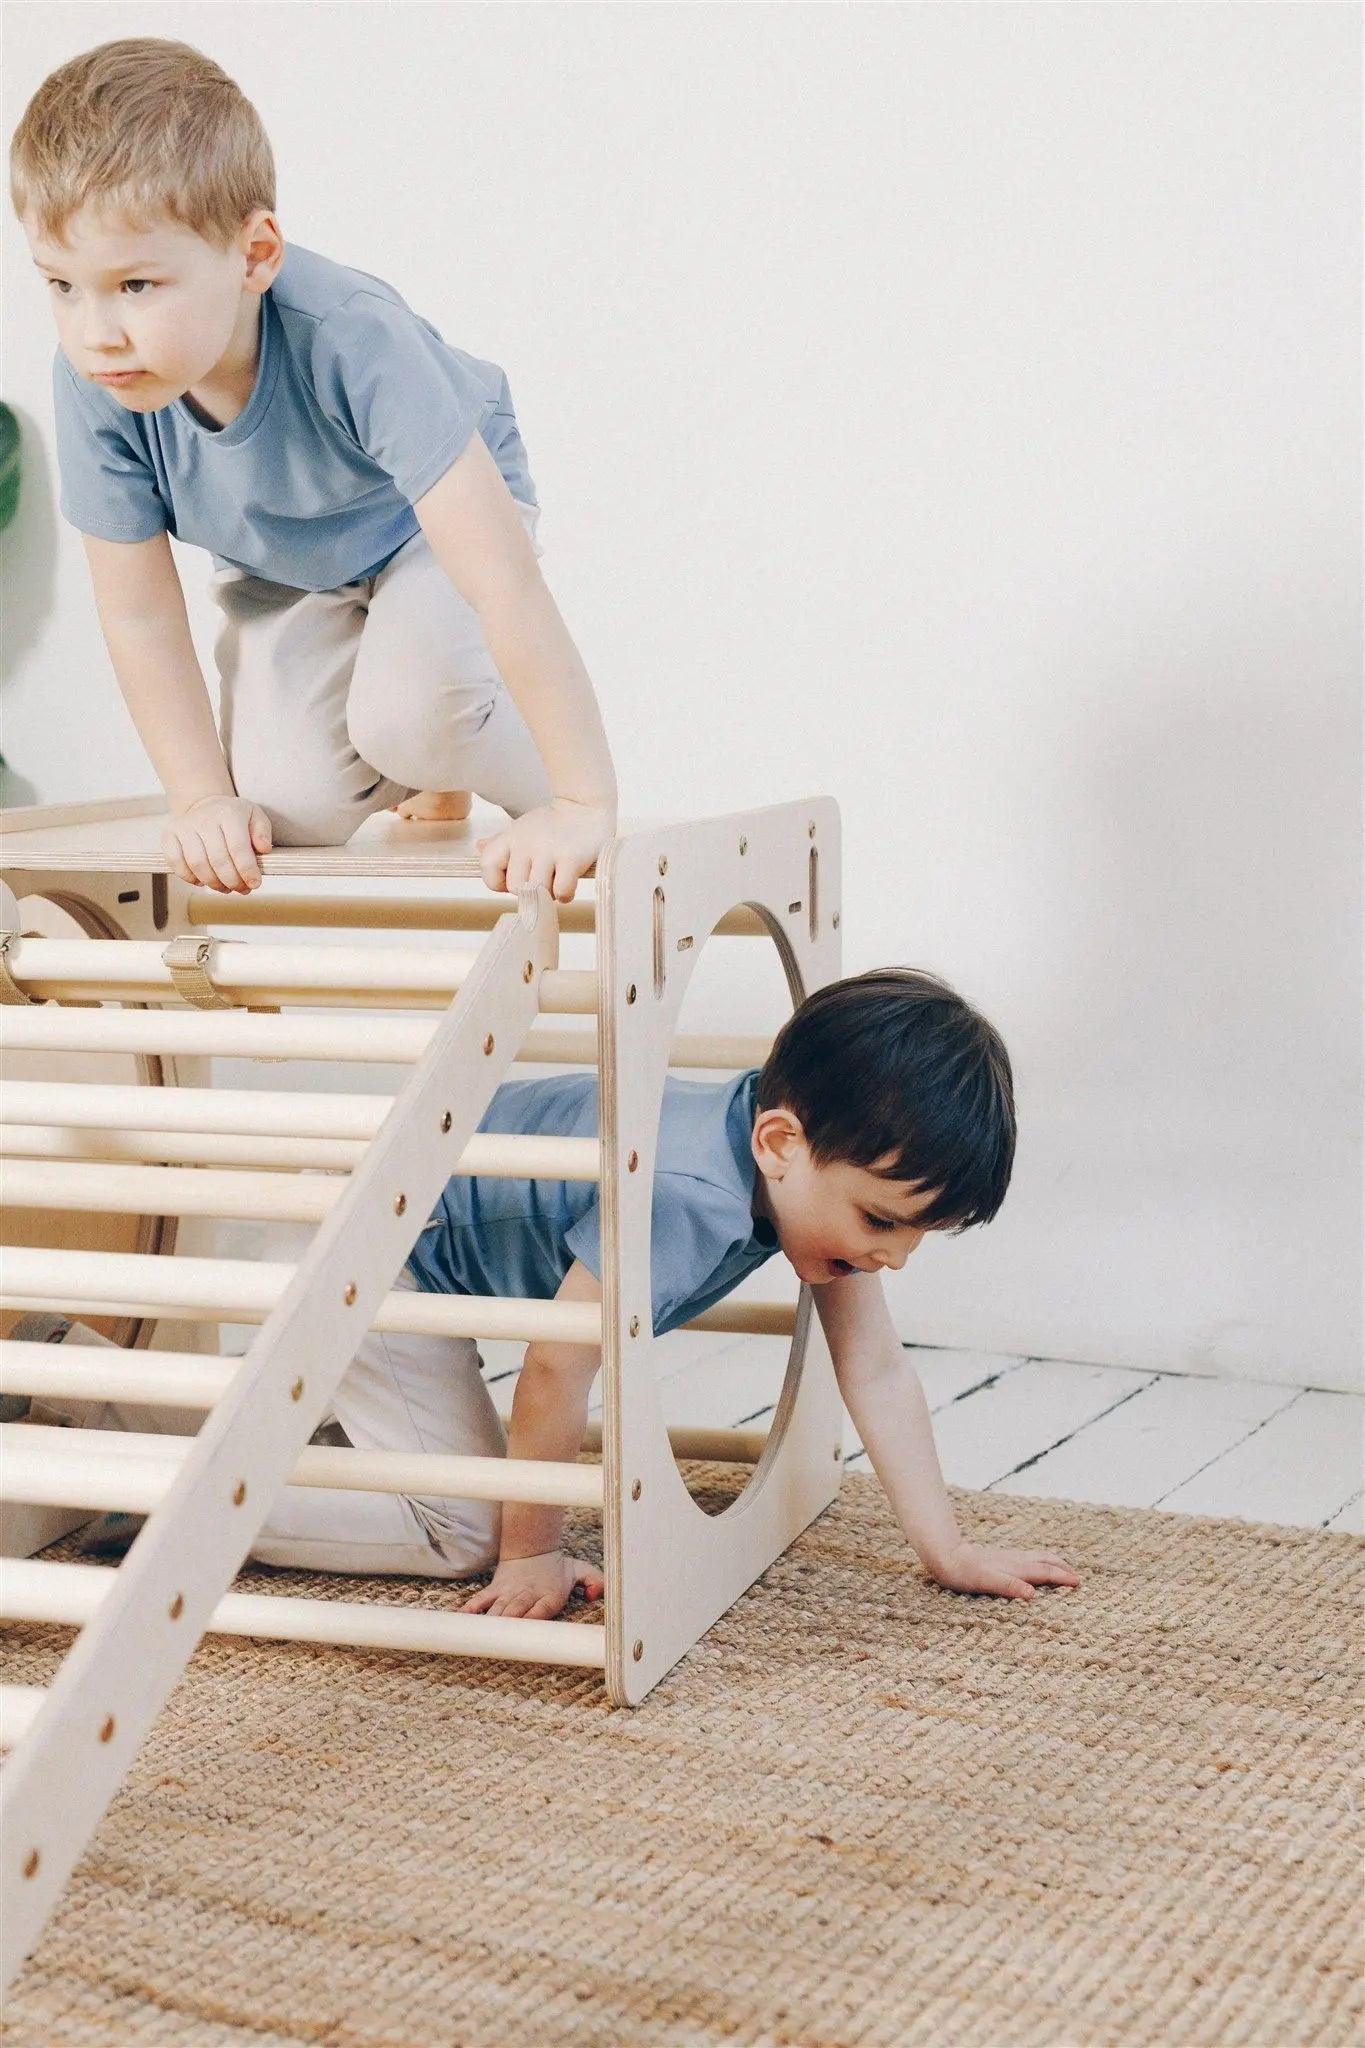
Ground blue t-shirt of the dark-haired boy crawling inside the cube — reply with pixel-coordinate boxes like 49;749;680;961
407;1067;778;1337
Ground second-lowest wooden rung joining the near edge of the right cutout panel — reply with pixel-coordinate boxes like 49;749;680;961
0;1421;602;1513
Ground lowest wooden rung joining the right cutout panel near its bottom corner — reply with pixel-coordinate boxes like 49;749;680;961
0;1559;606;1671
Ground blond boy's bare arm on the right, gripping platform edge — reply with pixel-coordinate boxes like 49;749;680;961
413;434;616;901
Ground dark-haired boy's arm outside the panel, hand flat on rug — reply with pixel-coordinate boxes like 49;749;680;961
814;1274;1081;1599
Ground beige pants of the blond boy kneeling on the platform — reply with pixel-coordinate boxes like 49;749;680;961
211;506;551;846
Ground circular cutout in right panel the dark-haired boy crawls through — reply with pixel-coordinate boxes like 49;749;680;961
651;905;798;1516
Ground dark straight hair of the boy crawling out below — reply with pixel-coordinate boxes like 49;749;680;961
755;967;1015;1235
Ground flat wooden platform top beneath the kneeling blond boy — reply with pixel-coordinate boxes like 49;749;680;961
0;797;642;881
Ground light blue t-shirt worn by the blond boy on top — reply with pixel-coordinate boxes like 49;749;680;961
53;244;536;590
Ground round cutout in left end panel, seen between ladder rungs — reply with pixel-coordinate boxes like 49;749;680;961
0;891;176;1348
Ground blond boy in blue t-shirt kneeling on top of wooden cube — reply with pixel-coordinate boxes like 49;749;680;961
10;37;616;901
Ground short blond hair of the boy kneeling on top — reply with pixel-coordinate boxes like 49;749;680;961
10;35;274;248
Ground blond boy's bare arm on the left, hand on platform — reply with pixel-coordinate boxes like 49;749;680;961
82;532;270;891
